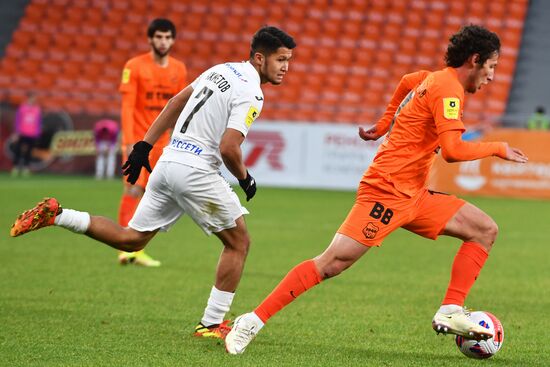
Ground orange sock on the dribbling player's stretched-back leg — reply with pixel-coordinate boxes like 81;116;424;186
254;260;323;323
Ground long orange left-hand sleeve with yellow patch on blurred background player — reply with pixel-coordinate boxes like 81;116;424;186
118;61;139;145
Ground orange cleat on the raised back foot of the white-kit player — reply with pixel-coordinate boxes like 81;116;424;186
10;198;61;237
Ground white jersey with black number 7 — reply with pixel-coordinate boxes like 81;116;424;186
159;61;264;170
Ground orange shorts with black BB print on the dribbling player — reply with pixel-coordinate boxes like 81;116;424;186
338;182;465;246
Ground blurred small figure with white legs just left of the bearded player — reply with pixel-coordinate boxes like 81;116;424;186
94;119;119;180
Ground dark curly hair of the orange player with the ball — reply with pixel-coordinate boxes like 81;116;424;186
445;24;500;68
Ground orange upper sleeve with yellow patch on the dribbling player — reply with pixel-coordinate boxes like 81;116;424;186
428;79;466;135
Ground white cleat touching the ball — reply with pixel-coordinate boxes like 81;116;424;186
432;309;493;340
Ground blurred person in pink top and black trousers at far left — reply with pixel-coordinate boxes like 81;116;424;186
11;92;42;177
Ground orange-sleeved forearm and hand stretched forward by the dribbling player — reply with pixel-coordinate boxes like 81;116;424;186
439;130;527;163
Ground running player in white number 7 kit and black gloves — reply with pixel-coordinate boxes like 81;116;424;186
11;26;296;338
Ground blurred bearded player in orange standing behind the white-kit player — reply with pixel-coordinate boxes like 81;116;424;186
118;18;187;266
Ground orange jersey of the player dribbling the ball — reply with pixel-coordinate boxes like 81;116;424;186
362;67;465;197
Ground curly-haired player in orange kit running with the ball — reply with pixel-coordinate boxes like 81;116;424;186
225;25;527;354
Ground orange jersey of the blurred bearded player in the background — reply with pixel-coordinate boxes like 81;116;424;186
119;52;187;147
